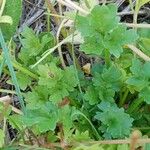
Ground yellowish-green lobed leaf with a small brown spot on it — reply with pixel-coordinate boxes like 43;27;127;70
38;63;78;103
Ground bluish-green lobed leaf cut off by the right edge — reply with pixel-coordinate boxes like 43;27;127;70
126;59;150;104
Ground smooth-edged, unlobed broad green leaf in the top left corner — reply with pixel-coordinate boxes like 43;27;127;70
0;0;22;40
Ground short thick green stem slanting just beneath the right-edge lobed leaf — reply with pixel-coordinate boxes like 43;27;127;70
127;98;143;114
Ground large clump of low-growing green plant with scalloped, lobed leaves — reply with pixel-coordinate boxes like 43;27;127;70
0;1;150;150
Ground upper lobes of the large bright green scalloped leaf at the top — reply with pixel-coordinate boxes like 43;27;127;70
76;5;119;36
